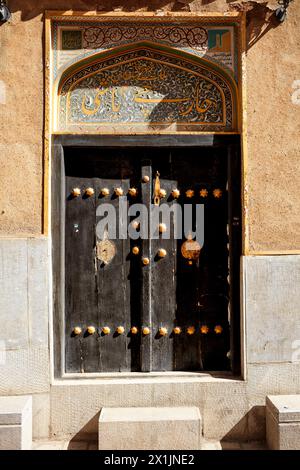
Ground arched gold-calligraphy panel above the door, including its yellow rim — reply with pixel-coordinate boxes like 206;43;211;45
55;42;238;134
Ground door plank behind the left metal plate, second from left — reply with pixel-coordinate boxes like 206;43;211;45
95;174;131;372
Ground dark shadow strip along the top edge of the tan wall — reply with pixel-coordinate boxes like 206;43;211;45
3;0;279;49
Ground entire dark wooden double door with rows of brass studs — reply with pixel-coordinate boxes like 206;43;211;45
65;148;236;373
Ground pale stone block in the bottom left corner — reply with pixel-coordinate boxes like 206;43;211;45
0;396;32;450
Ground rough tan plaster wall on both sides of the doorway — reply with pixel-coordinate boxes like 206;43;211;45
0;0;300;253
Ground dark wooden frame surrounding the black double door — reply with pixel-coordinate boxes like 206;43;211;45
51;134;243;378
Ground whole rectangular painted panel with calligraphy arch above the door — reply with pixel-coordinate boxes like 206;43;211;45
52;17;238;133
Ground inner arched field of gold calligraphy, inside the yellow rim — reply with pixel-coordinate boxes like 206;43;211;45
59;49;233;130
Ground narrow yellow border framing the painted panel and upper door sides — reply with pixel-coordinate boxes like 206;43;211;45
43;10;246;254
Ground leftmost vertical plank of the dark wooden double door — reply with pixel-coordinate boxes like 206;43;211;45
65;176;98;372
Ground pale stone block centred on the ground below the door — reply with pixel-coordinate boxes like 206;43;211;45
98;407;202;450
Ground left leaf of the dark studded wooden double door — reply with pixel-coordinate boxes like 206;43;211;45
66;153;139;372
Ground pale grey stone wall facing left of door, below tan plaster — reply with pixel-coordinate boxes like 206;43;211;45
0;237;50;437
